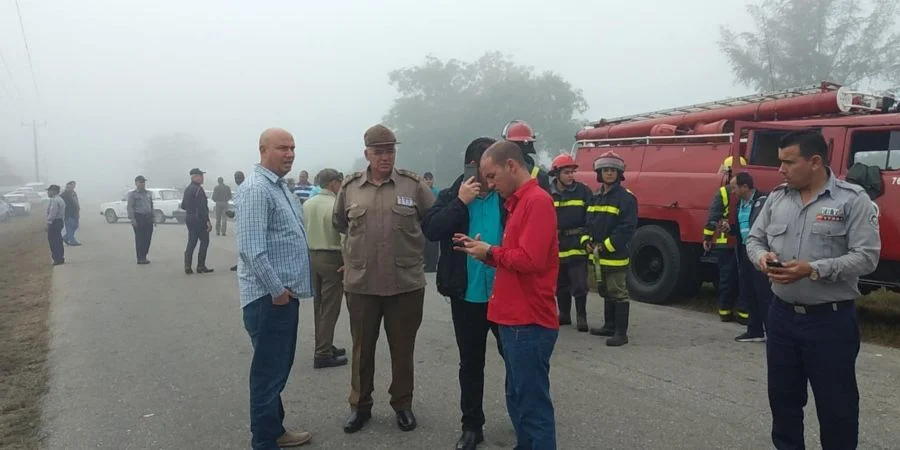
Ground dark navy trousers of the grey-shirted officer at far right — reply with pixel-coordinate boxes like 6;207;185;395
766;298;859;450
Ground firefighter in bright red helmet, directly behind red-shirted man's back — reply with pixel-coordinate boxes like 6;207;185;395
550;155;591;332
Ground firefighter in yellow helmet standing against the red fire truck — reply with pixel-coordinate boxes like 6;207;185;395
703;156;750;325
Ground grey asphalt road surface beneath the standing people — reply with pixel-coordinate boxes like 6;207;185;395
37;216;900;450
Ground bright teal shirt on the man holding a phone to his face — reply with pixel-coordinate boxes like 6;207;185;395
465;191;503;303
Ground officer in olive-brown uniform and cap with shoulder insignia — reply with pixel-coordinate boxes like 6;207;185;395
333;125;434;433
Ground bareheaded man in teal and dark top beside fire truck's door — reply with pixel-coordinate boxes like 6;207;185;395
731;172;772;342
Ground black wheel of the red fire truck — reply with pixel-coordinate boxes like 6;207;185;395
628;225;681;304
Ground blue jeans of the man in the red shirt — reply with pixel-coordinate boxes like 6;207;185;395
499;325;559;450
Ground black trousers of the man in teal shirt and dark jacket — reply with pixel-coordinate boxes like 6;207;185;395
450;299;503;432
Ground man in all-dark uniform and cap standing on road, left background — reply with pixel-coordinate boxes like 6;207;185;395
181;169;213;275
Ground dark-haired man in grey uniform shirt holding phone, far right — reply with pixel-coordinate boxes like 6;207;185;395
747;131;881;450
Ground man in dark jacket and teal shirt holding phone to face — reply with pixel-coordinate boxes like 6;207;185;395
422;138;506;450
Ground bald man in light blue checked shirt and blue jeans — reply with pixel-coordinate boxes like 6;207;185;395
235;128;312;450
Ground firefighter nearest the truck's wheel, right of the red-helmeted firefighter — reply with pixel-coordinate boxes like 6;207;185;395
586;151;637;347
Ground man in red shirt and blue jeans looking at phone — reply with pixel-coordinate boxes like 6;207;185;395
455;142;559;450
